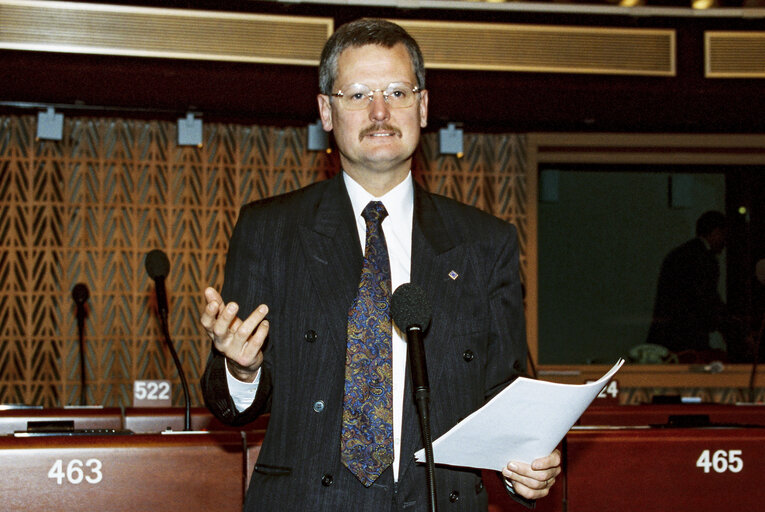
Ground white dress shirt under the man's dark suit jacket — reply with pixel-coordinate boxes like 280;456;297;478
226;172;414;481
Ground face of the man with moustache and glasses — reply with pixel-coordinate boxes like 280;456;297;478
318;44;428;190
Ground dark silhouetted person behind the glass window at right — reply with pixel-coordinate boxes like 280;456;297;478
648;211;727;363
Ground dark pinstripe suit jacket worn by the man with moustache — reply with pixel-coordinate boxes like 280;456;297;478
201;174;526;512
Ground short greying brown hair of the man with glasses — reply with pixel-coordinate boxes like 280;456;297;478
319;18;425;94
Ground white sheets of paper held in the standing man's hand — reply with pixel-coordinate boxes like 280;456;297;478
414;359;624;471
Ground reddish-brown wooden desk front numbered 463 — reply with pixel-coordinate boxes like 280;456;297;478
0;432;246;512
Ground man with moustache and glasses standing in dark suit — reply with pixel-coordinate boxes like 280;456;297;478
201;20;560;512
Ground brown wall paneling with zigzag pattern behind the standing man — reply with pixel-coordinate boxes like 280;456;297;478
0;116;529;407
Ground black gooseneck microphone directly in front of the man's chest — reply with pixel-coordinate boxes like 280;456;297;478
390;283;437;512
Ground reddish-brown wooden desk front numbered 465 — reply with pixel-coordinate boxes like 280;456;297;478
566;428;765;512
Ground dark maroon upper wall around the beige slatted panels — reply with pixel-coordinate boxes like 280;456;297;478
0;0;765;133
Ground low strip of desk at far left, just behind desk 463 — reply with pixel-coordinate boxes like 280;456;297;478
0;407;122;434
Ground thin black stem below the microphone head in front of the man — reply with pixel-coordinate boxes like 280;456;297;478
407;326;438;512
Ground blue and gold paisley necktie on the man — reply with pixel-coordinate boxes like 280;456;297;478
340;201;393;487
